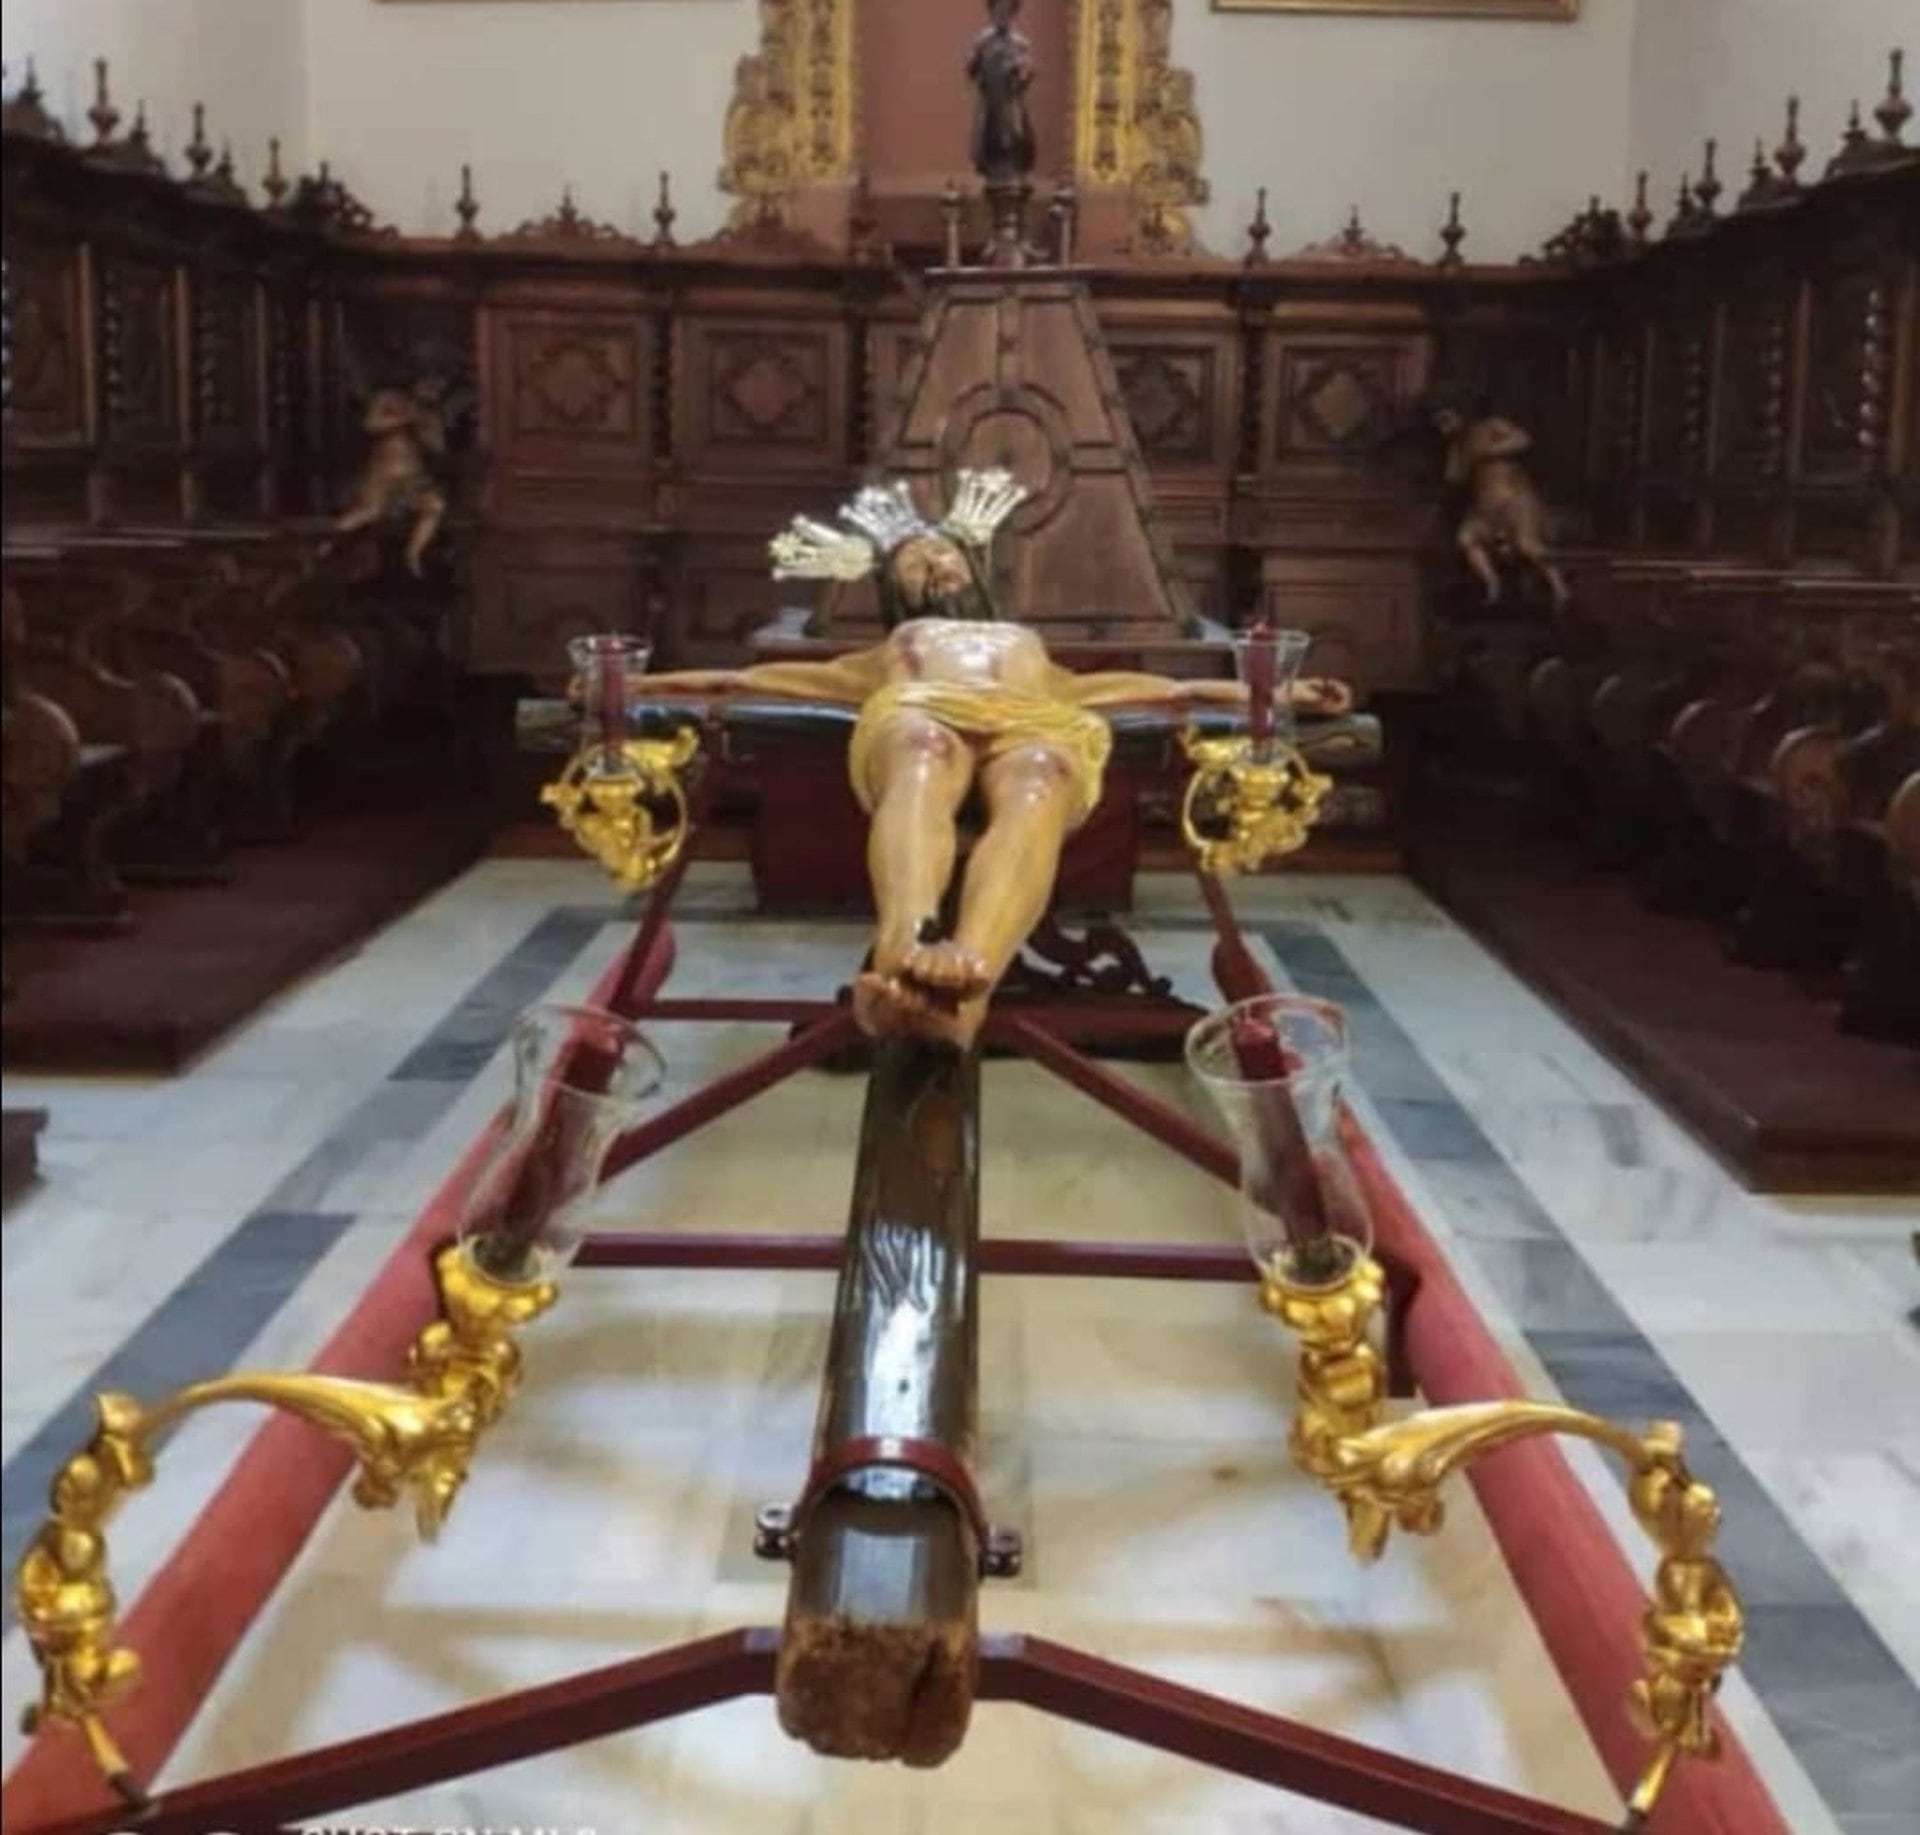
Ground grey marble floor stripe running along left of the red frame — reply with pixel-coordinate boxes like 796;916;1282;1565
0;906;618;1632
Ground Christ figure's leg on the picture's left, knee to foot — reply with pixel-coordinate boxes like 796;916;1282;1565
854;712;973;1033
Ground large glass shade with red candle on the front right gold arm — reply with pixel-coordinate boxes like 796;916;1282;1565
1187;994;1373;1286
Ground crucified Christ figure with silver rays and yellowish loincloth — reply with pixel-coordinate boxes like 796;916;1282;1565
639;472;1352;1050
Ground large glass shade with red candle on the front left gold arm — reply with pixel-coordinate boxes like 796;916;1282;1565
459;1006;666;1280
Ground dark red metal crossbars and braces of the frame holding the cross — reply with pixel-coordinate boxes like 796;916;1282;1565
0;856;1651;1835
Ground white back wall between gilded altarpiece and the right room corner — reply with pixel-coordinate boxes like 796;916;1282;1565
1173;0;1635;261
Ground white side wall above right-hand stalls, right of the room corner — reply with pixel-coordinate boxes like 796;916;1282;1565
1630;0;1920;219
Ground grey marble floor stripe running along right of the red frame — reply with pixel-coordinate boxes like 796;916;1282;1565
1260;923;1920;1835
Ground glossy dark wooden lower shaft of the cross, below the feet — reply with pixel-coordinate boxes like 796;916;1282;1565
760;1040;1018;1766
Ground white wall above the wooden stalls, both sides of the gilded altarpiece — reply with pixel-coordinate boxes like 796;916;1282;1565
4;0;1920;261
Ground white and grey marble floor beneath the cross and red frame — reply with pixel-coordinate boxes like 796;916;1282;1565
0;860;1920;1835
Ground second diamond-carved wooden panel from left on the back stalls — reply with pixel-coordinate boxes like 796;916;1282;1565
676;322;848;472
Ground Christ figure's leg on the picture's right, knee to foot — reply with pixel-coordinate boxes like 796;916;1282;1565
906;745;1081;1046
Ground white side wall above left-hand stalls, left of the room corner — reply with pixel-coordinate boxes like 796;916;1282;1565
0;0;307;188
